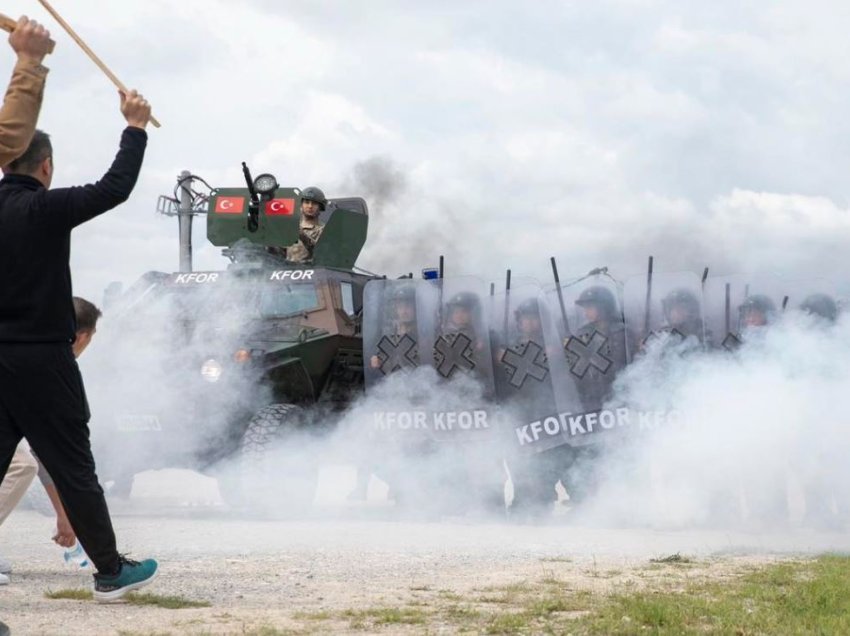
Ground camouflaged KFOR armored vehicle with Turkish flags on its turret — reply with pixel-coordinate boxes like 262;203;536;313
84;170;374;506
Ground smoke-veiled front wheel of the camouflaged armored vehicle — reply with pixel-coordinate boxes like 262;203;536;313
219;404;319;517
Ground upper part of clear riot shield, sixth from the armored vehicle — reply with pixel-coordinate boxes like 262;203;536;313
704;274;788;351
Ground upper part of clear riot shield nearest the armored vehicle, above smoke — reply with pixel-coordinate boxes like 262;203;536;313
363;279;436;389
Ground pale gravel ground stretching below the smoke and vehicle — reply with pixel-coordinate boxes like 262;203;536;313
0;475;850;635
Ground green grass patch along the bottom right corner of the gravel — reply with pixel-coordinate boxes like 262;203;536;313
284;555;850;635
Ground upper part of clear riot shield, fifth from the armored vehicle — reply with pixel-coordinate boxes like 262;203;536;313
623;272;711;362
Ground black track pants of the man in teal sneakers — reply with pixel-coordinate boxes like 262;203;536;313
0;343;118;573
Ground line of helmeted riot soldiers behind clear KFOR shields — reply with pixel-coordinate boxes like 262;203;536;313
354;262;839;510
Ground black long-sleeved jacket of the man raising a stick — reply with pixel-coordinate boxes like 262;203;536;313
0;127;148;342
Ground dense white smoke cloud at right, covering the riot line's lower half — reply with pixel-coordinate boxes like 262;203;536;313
581;313;850;530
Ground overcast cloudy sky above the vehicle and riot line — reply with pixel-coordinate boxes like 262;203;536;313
0;0;850;300
